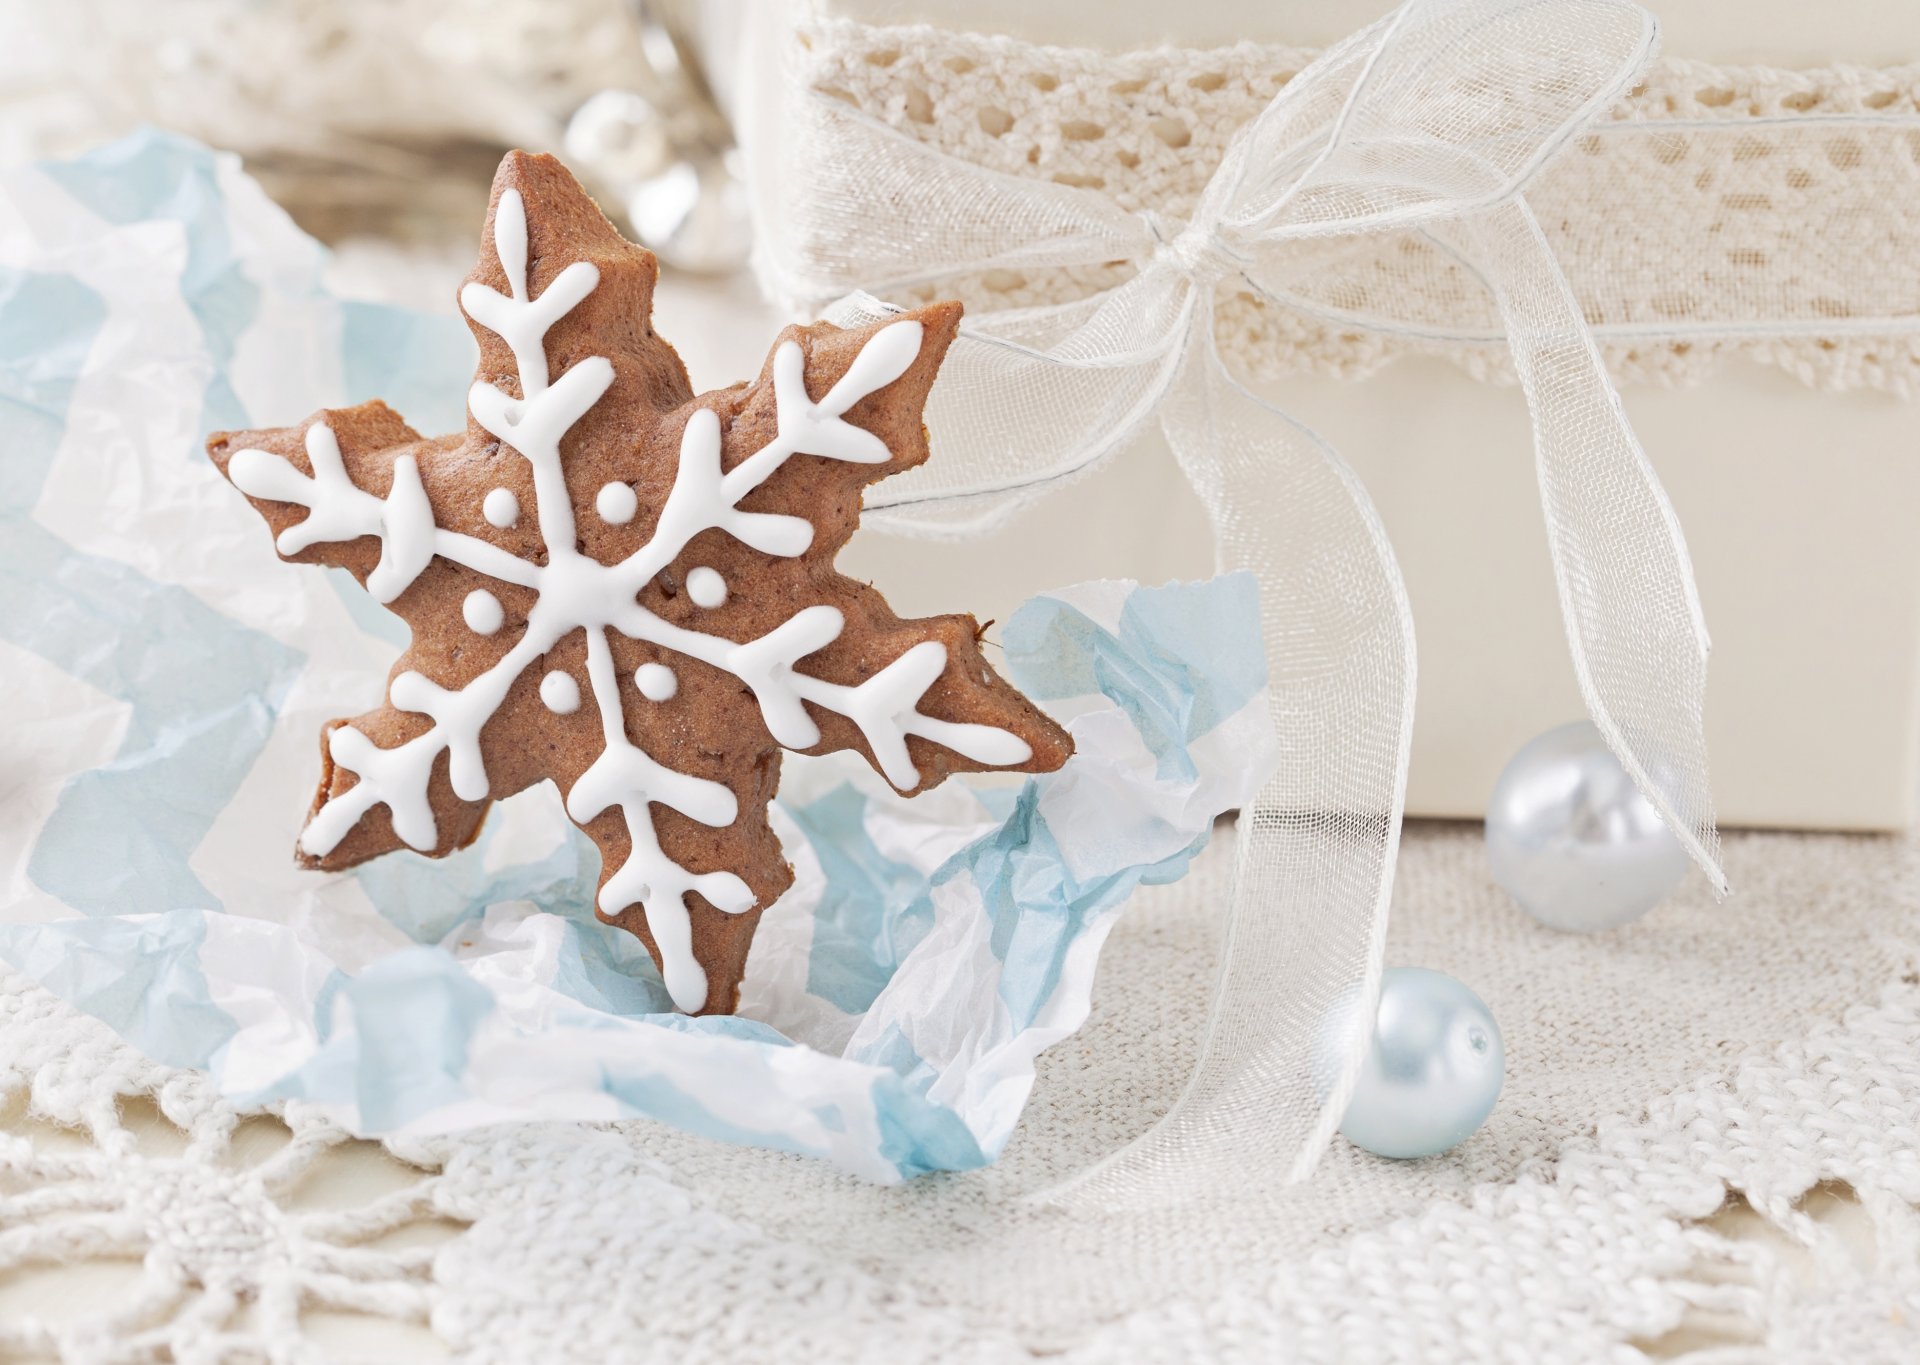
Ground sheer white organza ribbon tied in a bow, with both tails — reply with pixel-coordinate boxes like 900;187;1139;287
755;0;1724;1208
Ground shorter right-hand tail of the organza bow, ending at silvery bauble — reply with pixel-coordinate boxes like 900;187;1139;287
1436;196;1728;895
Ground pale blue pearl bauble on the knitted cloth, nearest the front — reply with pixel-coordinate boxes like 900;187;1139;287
1340;968;1507;1158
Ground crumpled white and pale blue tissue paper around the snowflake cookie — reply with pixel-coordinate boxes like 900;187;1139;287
0;132;1275;1181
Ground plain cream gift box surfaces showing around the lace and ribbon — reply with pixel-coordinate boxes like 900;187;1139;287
718;0;1920;829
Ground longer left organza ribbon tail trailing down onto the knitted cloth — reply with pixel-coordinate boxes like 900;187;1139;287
1041;307;1415;1211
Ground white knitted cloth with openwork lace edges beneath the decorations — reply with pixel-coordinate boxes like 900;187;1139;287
0;826;1920;1363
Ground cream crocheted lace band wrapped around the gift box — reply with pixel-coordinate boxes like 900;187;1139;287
795;15;1920;394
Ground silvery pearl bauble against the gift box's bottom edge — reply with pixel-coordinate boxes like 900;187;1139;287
1486;720;1688;933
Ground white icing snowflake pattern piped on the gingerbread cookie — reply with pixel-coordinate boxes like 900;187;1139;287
274;190;1031;1012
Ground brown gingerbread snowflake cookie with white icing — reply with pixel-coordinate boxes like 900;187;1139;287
220;152;1071;1014
